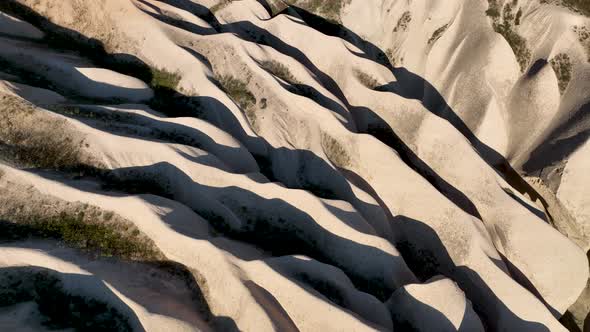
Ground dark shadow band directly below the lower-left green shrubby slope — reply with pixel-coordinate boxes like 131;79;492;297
0;220;238;331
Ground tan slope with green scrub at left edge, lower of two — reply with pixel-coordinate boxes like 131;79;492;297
0;184;164;260
